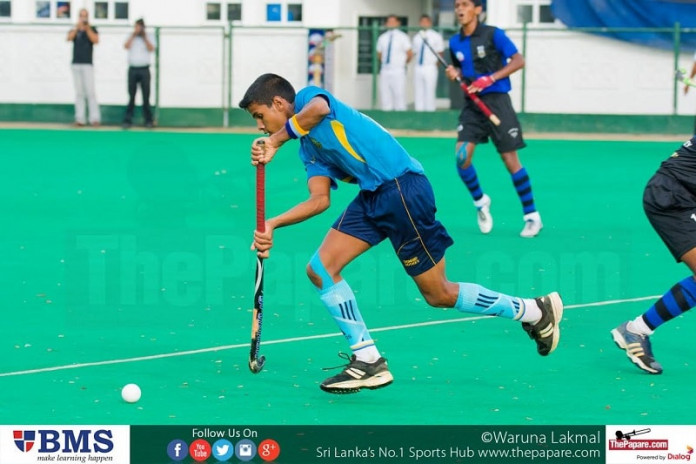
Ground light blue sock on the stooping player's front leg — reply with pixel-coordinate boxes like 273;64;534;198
319;280;379;359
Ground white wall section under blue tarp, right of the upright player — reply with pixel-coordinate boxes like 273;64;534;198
511;31;684;114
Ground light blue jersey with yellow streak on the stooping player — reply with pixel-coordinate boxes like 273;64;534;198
295;87;423;191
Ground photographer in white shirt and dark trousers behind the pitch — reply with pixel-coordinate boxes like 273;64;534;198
123;18;155;129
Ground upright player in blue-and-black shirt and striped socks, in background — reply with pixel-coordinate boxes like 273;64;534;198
446;0;543;238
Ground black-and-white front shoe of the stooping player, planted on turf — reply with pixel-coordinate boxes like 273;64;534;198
319;353;394;394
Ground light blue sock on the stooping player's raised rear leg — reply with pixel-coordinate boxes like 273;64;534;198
454;282;524;320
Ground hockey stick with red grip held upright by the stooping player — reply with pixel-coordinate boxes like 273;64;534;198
249;140;266;374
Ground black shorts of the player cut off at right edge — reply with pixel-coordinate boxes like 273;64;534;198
643;171;696;262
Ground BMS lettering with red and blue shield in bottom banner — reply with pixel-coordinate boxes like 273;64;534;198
13;429;114;453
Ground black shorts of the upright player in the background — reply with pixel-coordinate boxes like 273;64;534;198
457;93;527;153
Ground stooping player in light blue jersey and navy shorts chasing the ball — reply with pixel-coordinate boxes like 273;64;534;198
239;74;563;393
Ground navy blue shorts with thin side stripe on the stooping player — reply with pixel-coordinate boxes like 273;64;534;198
332;173;454;276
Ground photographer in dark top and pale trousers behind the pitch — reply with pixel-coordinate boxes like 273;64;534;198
68;8;101;127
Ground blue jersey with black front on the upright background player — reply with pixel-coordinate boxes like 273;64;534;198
449;24;518;95
